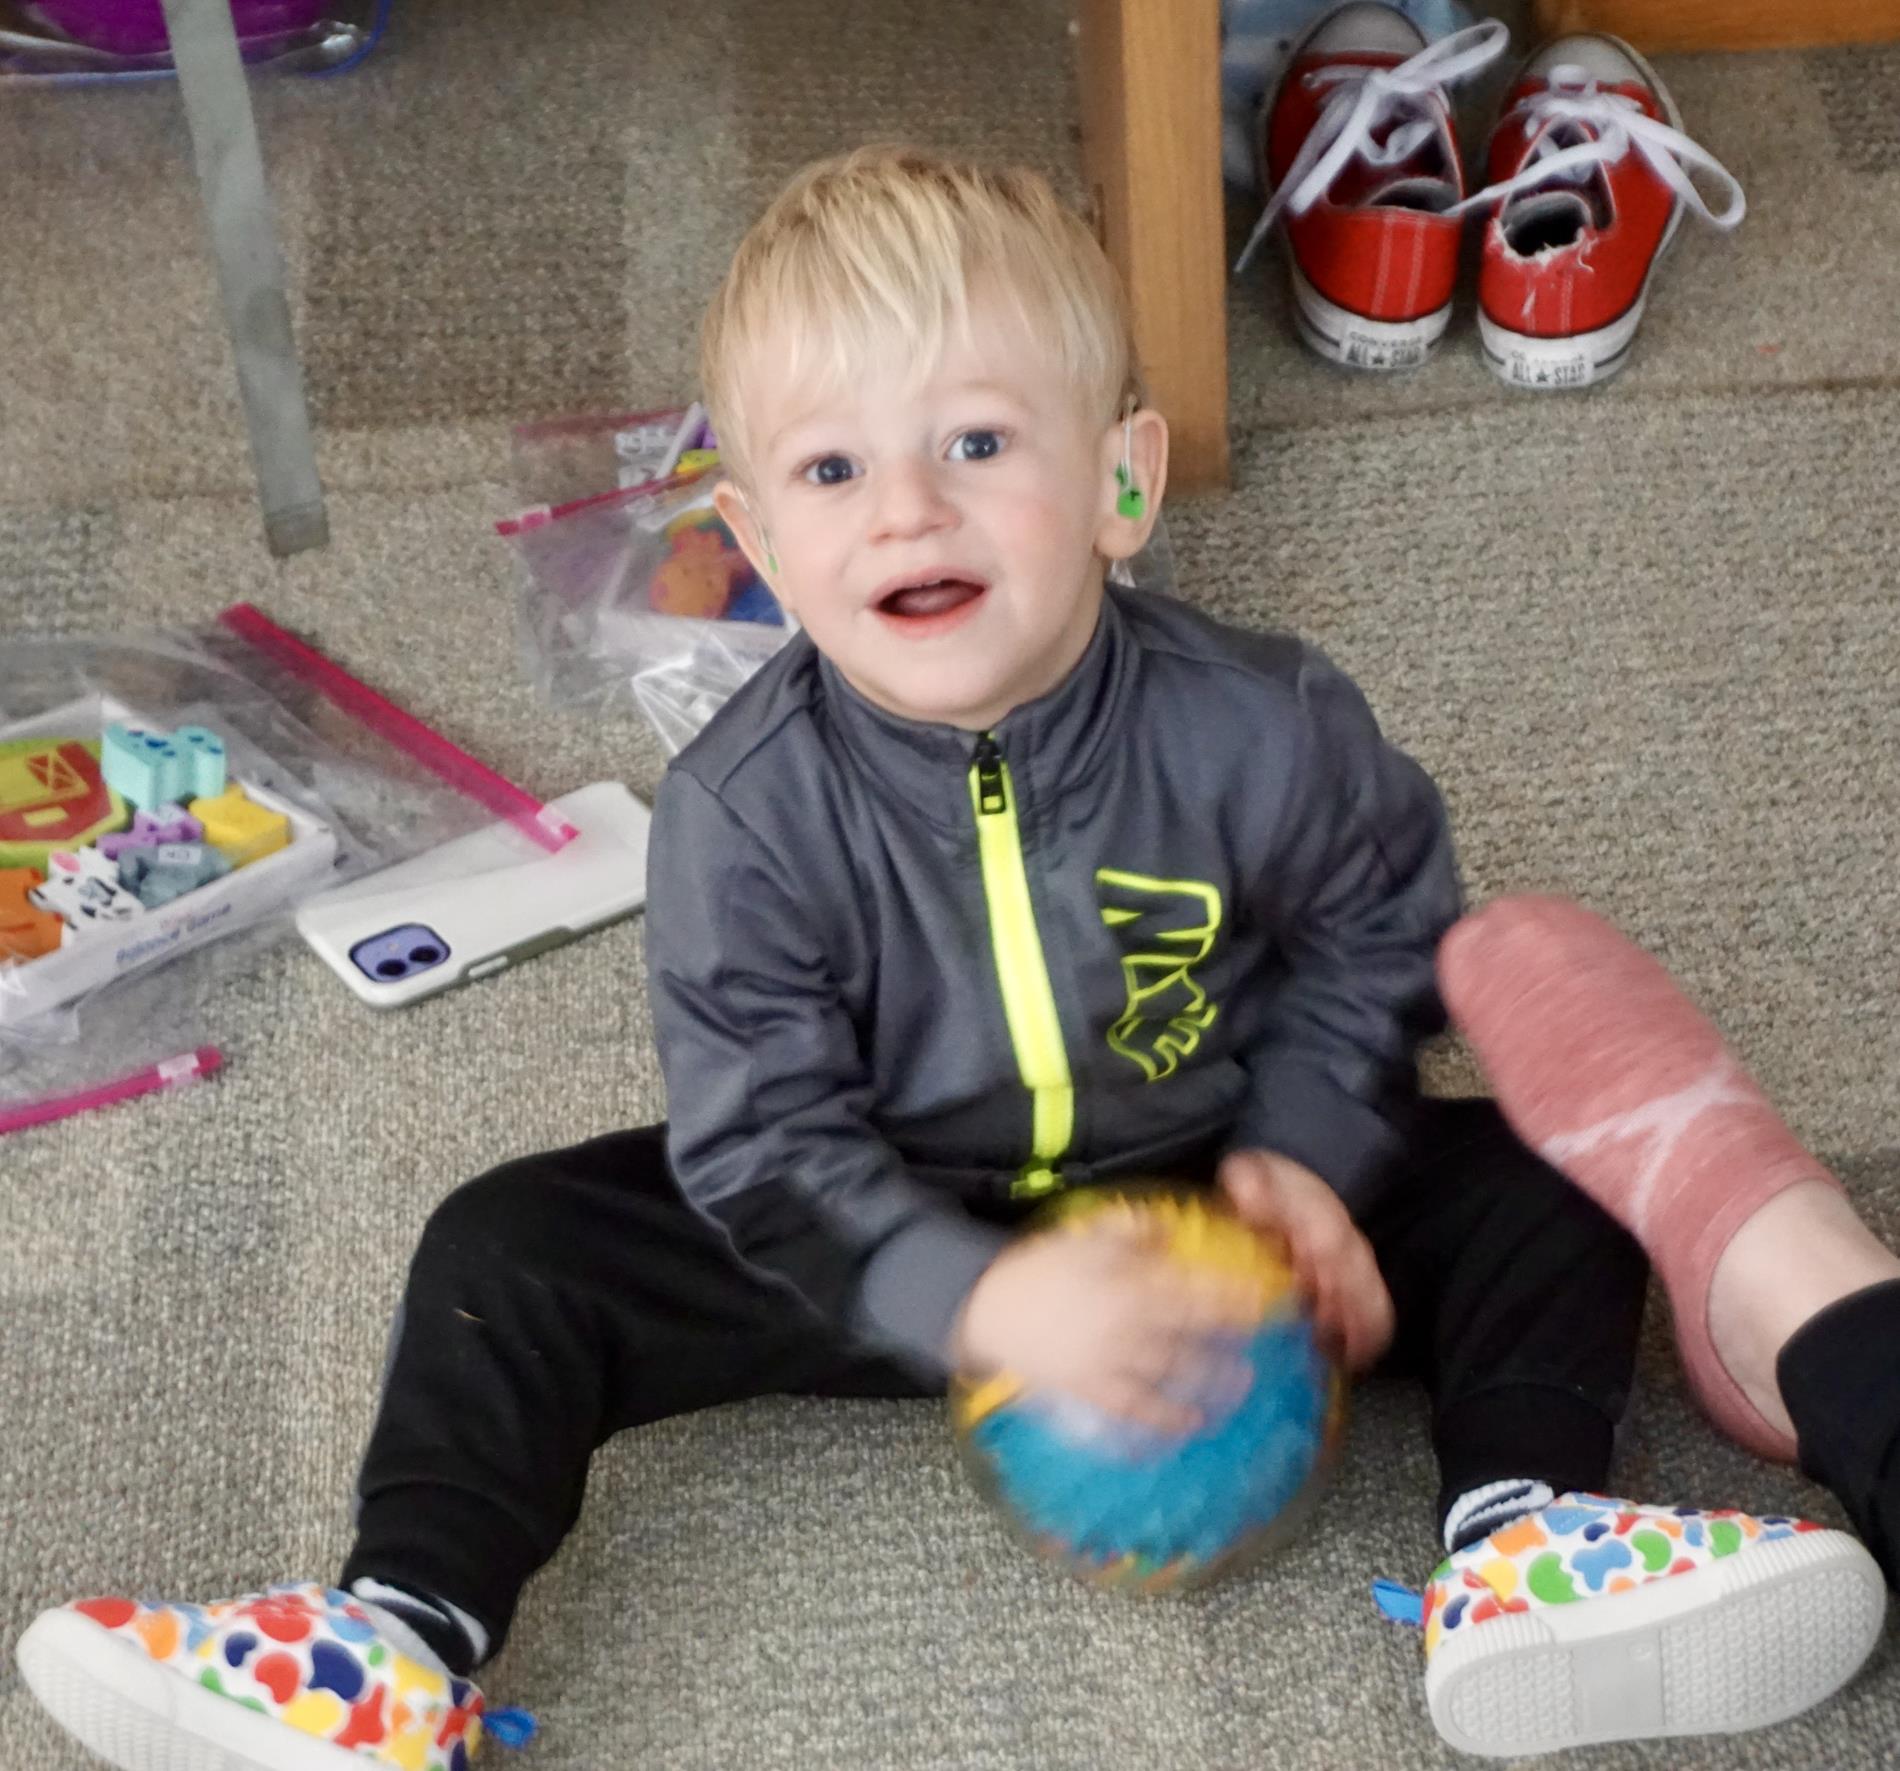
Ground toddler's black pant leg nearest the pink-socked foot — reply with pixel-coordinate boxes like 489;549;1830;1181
1364;1100;1649;1518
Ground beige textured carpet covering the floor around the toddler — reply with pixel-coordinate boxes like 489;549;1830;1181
0;0;1900;1771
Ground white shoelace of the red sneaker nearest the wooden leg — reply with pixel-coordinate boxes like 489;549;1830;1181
1233;19;1511;272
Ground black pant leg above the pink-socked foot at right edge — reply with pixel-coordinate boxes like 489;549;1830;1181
1775;1279;1900;1589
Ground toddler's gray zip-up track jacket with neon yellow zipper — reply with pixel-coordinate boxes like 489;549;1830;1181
648;589;1457;1370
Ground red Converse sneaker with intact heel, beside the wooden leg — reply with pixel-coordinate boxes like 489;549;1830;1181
1235;0;1509;369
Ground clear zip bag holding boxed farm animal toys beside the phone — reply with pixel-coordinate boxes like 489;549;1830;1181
0;604;574;1131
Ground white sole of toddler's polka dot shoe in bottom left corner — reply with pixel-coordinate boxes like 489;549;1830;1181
13;1611;369;1771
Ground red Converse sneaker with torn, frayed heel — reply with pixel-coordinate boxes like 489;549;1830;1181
1471;36;1744;388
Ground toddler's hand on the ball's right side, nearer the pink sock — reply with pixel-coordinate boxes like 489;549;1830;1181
1220;1150;1393;1372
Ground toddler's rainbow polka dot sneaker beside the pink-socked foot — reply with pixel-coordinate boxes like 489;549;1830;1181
1417;1494;1887;1758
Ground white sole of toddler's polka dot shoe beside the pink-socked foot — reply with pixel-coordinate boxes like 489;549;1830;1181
1425;1532;1887;1758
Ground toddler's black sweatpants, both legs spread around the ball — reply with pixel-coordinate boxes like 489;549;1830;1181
344;1100;1647;1651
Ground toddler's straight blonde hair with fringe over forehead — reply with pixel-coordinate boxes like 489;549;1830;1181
699;146;1140;477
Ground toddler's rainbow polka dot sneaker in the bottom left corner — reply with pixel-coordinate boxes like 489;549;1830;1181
15;1587;532;1771
